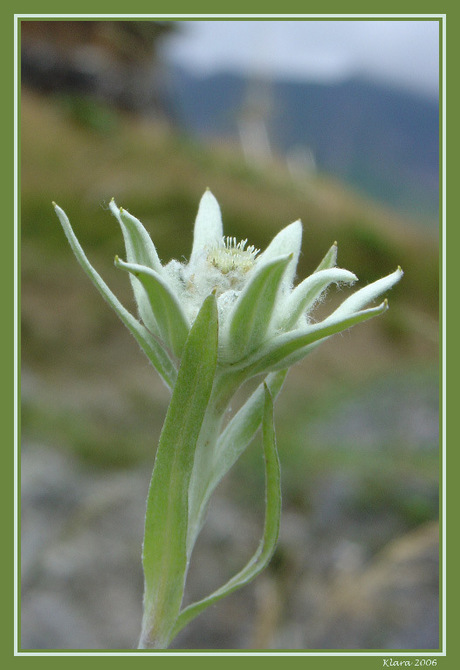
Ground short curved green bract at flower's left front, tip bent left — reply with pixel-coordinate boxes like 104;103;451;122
115;258;189;357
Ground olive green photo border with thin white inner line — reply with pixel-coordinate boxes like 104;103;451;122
7;0;452;670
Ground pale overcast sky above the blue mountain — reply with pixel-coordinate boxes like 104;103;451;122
165;20;439;96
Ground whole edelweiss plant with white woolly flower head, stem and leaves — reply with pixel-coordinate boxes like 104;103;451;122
55;191;402;649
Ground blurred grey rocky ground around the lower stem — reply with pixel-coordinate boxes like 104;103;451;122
21;443;439;649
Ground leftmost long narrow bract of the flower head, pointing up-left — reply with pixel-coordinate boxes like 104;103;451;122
53;203;177;388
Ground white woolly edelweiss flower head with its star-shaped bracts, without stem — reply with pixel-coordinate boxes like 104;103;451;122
55;190;403;386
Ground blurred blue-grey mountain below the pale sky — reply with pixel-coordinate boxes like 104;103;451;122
170;67;439;223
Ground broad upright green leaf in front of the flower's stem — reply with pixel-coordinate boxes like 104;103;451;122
141;295;217;647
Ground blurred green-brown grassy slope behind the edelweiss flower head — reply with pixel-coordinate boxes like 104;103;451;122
21;91;438;499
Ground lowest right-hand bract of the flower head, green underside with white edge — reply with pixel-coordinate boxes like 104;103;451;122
240;300;388;376
